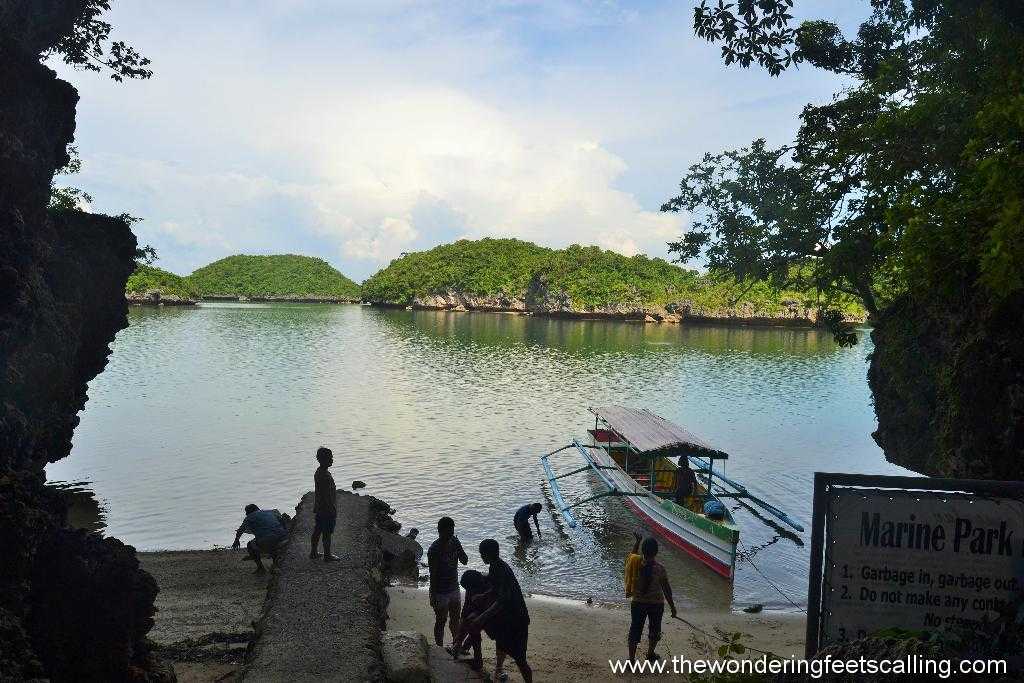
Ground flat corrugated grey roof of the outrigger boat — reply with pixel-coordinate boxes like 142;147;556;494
590;405;729;460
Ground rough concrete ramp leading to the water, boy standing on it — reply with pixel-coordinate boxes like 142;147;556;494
243;492;387;683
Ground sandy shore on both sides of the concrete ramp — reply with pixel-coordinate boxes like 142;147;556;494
138;549;806;683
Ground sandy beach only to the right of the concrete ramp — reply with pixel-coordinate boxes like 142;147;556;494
387;586;805;681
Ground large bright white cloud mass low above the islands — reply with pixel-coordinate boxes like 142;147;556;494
79;88;680;272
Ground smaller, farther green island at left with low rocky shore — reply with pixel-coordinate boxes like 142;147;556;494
125;254;359;305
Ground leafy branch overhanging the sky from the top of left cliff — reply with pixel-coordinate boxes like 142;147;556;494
42;0;153;83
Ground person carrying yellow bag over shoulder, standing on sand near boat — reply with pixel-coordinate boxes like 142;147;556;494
625;532;676;661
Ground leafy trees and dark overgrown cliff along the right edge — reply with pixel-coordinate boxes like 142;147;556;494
679;0;1024;479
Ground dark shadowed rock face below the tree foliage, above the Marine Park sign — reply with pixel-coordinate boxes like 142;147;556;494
868;293;1024;480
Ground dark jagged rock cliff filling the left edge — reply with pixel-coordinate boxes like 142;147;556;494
0;0;173;680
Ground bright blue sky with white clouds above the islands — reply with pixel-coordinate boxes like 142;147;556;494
51;0;866;281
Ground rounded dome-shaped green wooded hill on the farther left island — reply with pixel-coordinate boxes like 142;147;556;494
186;254;359;301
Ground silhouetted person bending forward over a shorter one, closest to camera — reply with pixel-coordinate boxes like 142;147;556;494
468;539;534;683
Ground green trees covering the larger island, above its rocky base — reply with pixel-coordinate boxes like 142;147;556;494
362;238;863;316
